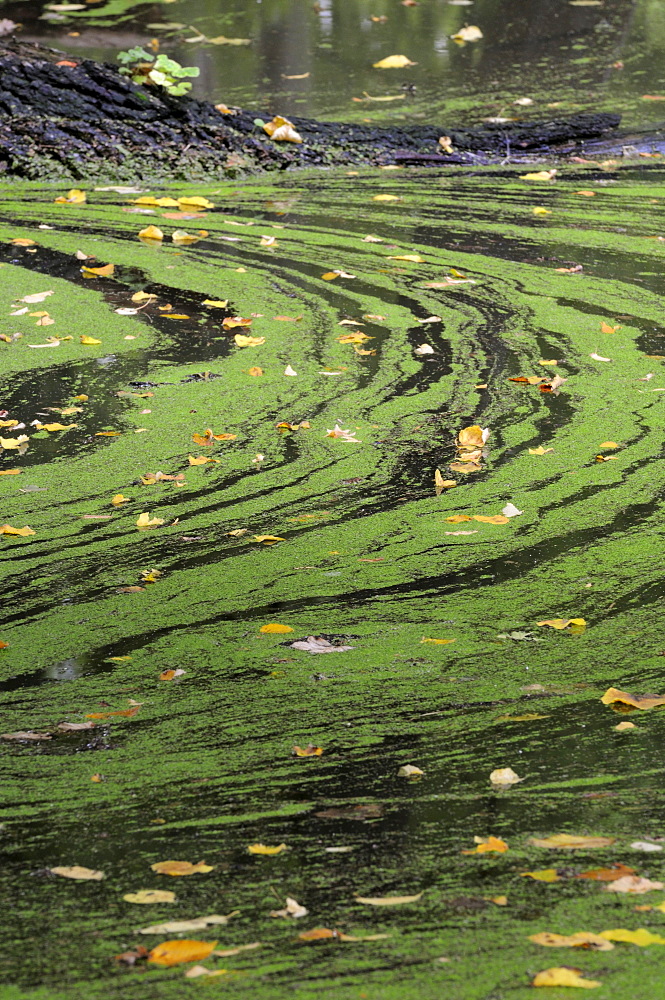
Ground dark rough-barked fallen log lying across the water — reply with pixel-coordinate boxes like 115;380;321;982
0;40;620;180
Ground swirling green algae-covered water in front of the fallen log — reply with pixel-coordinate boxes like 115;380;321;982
0;167;665;1000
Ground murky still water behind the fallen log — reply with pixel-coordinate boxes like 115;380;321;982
10;0;665;126
